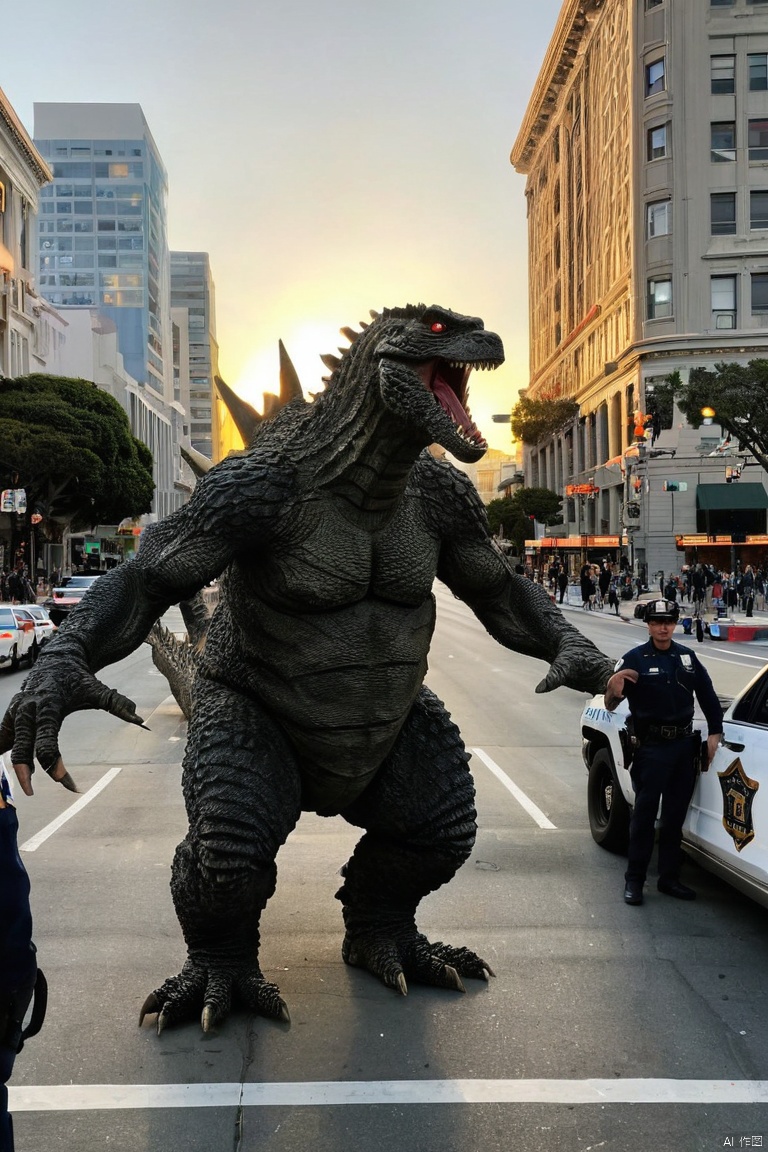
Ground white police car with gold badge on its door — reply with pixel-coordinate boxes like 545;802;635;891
581;665;768;908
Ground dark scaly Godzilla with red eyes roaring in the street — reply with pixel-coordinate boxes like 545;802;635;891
0;305;613;1031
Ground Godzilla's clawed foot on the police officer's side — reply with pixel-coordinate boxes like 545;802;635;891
341;930;495;996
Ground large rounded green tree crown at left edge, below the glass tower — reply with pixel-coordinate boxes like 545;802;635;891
0;374;154;529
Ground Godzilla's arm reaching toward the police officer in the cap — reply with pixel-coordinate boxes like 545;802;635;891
438;458;614;692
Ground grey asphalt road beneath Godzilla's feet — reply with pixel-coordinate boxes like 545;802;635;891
0;590;768;1152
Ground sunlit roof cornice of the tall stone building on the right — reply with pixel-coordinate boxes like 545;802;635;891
510;0;603;175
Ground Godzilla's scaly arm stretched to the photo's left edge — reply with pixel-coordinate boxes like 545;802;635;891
0;456;288;793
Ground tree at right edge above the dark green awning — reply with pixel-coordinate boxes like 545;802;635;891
654;359;768;469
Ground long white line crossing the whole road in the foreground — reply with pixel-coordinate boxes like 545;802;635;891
9;1079;768;1112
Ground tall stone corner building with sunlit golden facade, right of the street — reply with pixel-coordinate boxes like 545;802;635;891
511;0;768;579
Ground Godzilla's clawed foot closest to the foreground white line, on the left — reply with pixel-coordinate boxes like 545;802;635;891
138;960;290;1036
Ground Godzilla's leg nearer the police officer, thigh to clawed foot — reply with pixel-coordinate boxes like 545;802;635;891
336;688;493;994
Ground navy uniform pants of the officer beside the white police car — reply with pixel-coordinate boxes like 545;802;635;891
625;736;698;881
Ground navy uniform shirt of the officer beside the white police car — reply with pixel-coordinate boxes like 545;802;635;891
615;637;723;736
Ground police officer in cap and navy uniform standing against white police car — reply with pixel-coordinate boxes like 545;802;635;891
606;599;723;904
